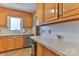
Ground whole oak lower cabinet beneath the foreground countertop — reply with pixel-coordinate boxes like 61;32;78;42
36;43;58;56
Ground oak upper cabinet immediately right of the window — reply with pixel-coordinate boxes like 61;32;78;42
23;13;33;28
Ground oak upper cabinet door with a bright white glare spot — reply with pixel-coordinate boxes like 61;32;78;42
44;3;58;23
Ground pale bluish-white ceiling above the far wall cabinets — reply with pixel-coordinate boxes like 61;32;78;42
0;3;36;13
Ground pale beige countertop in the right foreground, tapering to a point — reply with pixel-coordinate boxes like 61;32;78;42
31;36;79;56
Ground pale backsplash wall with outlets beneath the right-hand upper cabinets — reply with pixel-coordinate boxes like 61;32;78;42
41;21;79;43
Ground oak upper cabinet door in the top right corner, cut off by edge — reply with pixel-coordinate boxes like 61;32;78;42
59;3;79;18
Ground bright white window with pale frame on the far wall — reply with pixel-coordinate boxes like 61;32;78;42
9;16;22;30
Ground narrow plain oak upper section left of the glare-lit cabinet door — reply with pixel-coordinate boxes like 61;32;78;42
35;3;44;24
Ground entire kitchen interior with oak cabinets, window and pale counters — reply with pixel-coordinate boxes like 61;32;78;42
0;3;79;56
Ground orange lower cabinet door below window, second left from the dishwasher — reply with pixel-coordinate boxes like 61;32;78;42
5;37;15;50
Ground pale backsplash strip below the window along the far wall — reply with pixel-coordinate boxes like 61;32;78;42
0;27;32;36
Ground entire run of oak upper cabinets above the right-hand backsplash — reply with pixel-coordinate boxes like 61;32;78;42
35;3;79;24
